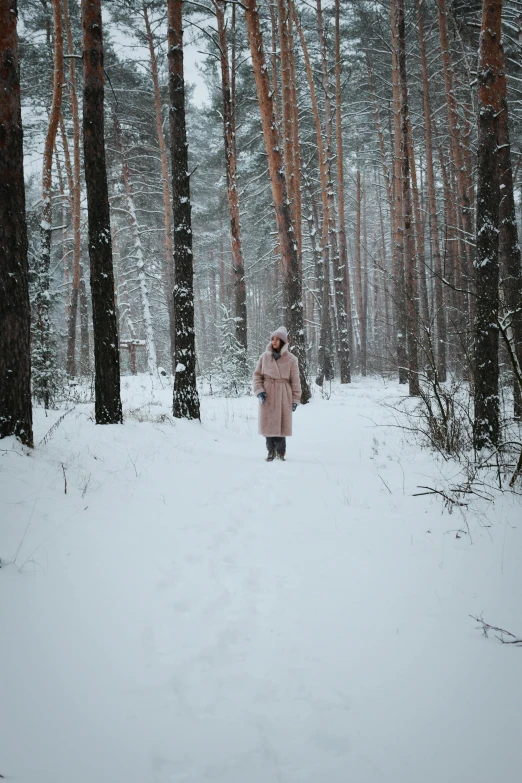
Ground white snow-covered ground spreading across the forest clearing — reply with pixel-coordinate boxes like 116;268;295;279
0;377;522;783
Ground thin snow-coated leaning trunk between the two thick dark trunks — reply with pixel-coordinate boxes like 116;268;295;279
113;107;158;375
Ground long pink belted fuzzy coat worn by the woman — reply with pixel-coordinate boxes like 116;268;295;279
254;344;301;438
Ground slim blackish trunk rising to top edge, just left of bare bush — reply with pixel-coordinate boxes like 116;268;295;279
395;0;420;397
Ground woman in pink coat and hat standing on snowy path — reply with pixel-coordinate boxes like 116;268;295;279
254;326;301;462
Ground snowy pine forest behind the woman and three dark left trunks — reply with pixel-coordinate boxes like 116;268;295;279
1;0;522;473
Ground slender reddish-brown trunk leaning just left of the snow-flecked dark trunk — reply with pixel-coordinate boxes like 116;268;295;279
143;5;176;374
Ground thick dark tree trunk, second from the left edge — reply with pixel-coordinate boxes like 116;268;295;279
81;0;122;424
